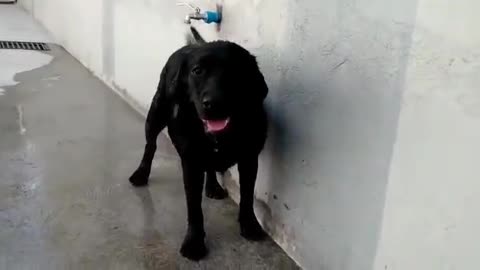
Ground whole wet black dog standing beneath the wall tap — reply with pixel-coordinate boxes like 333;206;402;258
130;28;268;260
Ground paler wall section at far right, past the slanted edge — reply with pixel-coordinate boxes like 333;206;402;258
375;0;480;270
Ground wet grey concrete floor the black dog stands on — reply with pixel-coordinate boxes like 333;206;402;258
0;46;296;270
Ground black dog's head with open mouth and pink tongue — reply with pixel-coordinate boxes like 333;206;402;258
183;29;268;133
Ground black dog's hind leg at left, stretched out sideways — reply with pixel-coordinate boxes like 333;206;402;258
129;72;170;187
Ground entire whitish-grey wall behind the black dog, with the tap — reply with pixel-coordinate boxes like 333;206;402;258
21;0;480;270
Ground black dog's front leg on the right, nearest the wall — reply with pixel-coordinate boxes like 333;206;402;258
238;157;266;241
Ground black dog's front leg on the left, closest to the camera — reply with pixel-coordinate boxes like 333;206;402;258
180;157;207;260
